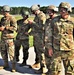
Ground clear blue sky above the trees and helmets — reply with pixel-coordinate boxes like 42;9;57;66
0;0;74;7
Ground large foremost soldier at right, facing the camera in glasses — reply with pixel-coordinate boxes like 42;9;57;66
47;2;74;75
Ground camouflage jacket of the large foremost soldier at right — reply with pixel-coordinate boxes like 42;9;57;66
48;16;74;51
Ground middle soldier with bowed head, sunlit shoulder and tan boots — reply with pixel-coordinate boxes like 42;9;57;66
31;5;47;73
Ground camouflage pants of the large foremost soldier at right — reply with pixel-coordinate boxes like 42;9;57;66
46;51;74;75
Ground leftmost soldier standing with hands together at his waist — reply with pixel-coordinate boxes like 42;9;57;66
0;5;17;72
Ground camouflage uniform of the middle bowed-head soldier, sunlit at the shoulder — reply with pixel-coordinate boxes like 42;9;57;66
34;11;46;63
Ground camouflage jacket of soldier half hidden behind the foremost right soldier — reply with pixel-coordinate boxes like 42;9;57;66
44;18;52;49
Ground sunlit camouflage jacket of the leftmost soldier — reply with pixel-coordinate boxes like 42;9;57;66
1;16;17;39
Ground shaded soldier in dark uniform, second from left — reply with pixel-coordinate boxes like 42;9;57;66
15;10;30;66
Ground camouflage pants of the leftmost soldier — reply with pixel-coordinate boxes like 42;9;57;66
1;39;15;63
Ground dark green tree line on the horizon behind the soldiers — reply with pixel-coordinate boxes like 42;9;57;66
0;6;74;15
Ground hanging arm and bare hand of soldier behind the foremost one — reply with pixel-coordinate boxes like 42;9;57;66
45;19;53;56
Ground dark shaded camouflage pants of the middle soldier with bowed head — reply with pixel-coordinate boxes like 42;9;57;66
34;34;45;66
